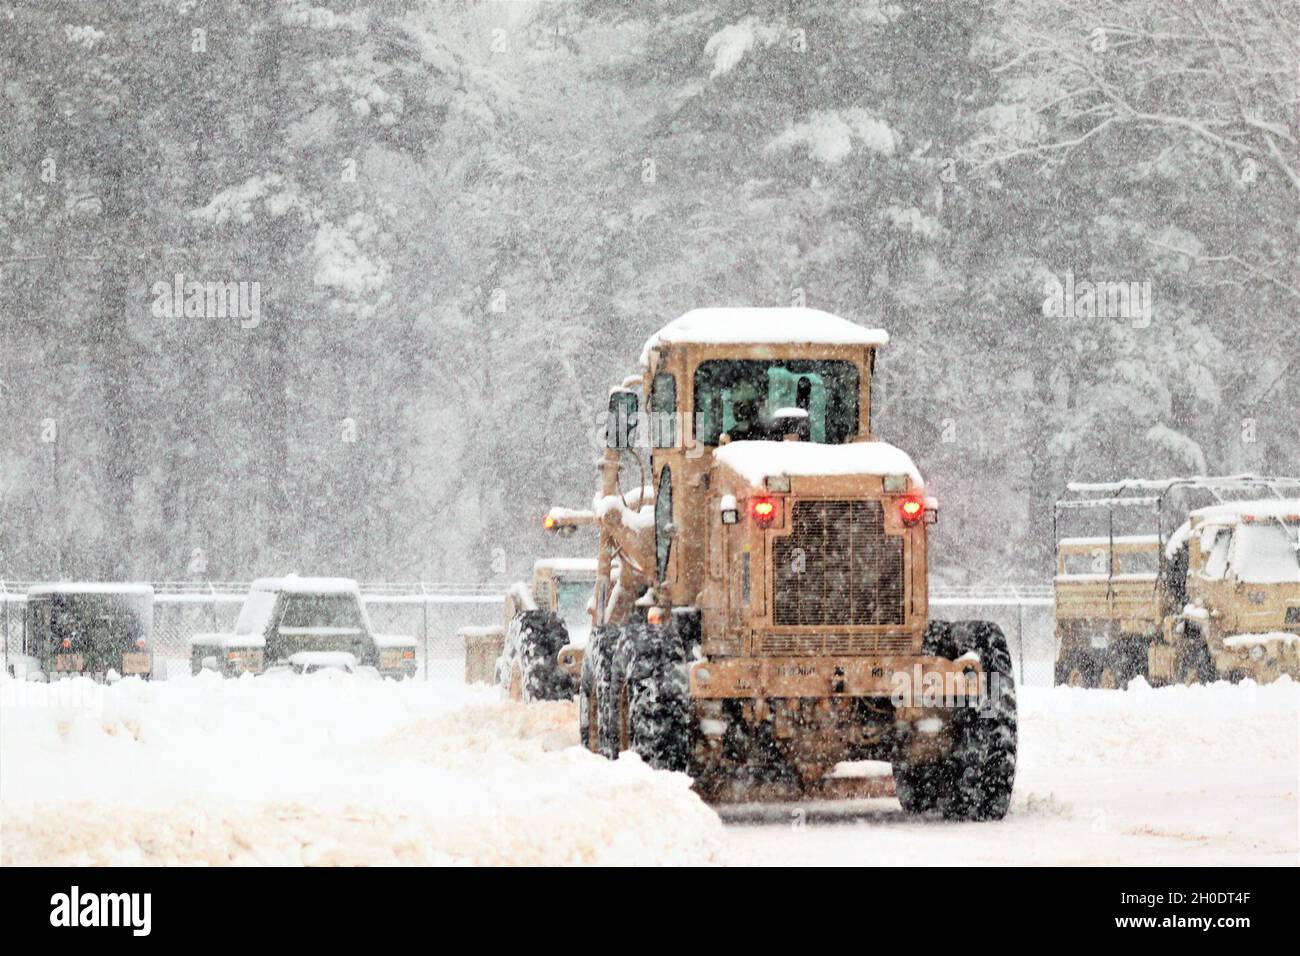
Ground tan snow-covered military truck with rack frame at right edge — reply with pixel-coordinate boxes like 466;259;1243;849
1054;475;1300;688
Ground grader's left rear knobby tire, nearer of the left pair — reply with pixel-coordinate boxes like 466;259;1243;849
615;624;690;771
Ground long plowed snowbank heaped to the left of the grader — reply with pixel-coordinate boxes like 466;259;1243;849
0;671;720;865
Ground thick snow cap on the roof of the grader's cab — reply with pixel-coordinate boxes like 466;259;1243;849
641;307;889;365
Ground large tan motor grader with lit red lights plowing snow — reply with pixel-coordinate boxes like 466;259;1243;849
546;308;1017;819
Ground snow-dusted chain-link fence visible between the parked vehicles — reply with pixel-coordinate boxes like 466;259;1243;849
0;583;1057;687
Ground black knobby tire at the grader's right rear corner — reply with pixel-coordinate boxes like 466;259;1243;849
894;620;1017;819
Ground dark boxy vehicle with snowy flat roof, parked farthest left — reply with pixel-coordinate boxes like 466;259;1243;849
10;584;153;680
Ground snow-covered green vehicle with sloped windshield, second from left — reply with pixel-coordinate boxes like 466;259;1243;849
190;575;416;679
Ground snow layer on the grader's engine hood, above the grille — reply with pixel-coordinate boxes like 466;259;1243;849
714;441;924;490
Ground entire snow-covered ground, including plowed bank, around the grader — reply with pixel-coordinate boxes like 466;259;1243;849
0;674;1300;865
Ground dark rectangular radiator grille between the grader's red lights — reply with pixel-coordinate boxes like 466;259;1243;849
772;501;904;629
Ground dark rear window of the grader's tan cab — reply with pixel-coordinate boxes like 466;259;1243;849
696;359;859;445
